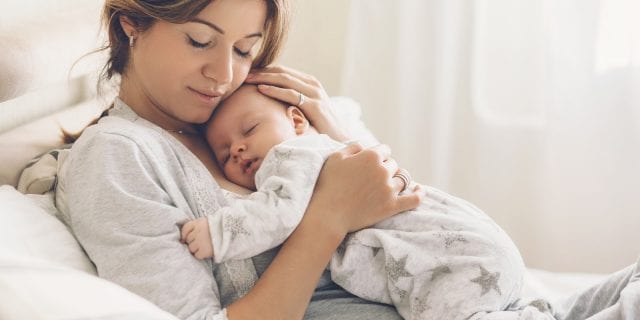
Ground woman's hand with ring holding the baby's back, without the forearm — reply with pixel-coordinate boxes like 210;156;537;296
308;144;421;234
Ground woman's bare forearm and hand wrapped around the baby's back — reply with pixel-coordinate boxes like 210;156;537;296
227;144;419;320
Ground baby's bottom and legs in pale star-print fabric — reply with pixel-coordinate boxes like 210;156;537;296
331;186;524;319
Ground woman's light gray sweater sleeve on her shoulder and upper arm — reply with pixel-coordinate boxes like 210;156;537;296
65;132;226;319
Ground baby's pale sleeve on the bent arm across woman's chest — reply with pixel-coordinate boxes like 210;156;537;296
207;140;324;263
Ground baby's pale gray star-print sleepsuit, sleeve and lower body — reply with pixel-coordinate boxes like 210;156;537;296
209;135;525;320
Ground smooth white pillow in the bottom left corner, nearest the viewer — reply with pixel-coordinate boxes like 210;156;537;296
0;256;177;320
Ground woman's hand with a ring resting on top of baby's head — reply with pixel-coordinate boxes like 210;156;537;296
246;66;349;141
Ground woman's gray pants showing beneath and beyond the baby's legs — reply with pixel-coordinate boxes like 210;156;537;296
305;260;640;320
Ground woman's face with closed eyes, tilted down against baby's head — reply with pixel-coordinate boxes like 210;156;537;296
121;0;267;124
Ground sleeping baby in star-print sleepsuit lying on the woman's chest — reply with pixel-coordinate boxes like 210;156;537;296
182;85;524;320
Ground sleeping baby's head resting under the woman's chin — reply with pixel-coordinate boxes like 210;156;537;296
205;84;315;190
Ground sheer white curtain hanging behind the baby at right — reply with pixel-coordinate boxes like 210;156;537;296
341;0;640;272
